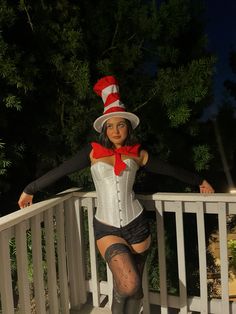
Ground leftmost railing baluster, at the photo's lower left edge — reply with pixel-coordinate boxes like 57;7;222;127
0;229;14;314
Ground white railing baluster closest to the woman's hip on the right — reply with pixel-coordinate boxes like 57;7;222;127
155;201;168;314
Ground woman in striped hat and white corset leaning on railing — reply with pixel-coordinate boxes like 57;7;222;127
18;76;214;314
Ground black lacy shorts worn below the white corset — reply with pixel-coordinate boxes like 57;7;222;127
93;211;150;244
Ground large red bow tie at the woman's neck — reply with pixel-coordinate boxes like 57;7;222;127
91;142;140;176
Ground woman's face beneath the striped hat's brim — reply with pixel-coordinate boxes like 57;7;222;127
106;117;128;148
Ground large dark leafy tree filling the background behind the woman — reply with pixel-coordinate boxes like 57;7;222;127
0;0;214;210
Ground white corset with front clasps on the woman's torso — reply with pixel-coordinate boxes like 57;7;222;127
91;159;143;228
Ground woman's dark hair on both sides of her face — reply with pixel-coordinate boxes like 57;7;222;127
98;119;137;148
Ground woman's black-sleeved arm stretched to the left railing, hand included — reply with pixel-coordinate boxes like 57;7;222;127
18;144;91;208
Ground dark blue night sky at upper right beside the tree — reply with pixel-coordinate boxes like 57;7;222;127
206;0;236;114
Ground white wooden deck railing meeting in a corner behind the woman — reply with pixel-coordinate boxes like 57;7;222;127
0;191;236;314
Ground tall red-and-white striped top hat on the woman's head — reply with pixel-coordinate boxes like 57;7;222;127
93;76;139;133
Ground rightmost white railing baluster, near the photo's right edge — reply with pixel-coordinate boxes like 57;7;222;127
218;202;229;314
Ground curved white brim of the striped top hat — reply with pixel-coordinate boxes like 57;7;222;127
93;111;139;133
